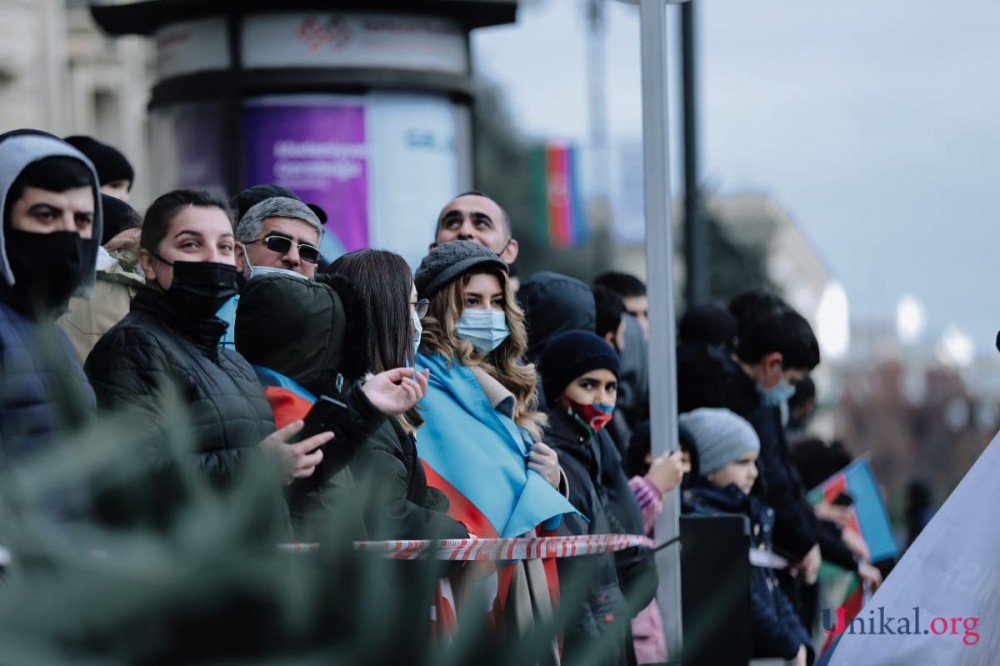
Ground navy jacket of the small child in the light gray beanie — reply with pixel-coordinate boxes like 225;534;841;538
691;483;811;659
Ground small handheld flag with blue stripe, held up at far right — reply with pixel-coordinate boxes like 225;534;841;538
809;457;898;562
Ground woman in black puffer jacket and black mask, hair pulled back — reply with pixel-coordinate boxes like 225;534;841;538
84;190;332;538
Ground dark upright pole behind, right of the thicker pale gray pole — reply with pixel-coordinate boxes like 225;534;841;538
681;0;709;307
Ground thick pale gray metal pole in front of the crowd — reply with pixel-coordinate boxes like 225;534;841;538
639;0;682;652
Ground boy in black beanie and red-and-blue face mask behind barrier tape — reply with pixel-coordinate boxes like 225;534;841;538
539;331;656;664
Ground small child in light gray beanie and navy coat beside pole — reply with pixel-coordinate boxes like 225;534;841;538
679;407;812;666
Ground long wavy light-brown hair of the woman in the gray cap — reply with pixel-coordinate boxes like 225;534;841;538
420;268;546;442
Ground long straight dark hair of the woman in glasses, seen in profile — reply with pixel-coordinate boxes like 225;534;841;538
324;249;424;432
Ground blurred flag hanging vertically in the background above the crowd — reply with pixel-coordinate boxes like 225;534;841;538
532;143;587;248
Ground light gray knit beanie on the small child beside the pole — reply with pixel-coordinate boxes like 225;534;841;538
678;407;760;476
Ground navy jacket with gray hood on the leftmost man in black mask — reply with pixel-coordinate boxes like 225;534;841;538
0;130;102;482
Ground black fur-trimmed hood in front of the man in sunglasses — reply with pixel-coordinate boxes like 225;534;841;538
236;274;372;395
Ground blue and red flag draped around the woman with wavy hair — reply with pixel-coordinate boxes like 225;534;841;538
417;354;575;537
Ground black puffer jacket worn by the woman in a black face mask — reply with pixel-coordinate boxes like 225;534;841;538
84;287;288;528
